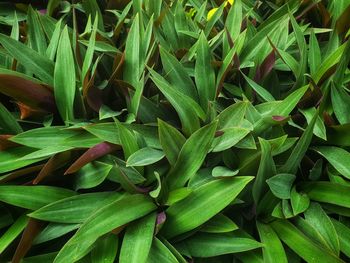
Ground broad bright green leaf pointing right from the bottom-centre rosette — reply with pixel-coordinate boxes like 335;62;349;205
162;176;253;238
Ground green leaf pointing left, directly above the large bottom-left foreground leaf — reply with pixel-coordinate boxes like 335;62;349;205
29;192;121;224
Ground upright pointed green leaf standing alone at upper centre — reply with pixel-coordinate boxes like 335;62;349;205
194;32;216;111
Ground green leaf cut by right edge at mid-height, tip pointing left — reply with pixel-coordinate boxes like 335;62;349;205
313;146;350;179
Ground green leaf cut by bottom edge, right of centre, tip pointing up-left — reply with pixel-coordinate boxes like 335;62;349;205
256;221;288;263
